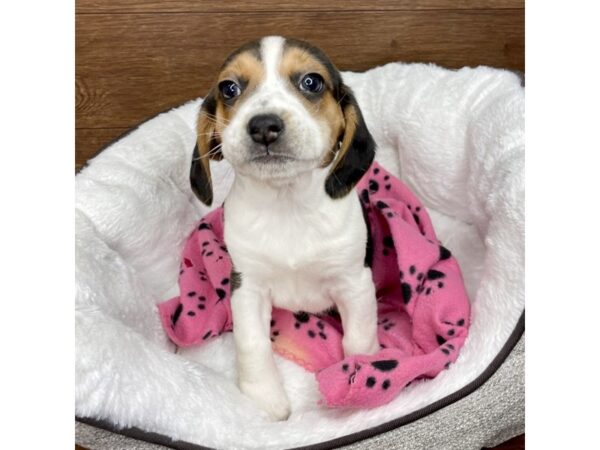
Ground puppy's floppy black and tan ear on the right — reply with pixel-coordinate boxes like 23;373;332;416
325;84;375;198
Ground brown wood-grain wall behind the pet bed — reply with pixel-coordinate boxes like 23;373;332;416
75;0;525;167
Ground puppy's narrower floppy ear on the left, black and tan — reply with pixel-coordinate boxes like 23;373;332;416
190;89;223;206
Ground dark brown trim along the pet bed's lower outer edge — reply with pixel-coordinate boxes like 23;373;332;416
76;311;525;450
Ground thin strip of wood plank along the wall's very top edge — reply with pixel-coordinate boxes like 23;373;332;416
75;0;525;14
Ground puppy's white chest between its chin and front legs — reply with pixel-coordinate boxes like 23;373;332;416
225;192;366;312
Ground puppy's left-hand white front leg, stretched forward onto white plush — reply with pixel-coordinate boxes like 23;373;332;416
231;285;290;420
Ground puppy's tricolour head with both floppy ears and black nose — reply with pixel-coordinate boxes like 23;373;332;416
190;37;375;205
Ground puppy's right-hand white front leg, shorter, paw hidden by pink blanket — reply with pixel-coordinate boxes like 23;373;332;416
335;267;379;356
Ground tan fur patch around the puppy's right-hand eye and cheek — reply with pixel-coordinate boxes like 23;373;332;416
279;47;344;167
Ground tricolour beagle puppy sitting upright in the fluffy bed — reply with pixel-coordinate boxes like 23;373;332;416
190;36;379;420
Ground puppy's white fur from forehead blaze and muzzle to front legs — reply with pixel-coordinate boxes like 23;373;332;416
221;37;379;420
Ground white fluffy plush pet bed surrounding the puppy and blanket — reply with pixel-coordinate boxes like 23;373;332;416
75;64;524;450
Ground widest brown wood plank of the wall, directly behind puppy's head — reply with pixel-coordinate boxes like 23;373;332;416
76;10;524;128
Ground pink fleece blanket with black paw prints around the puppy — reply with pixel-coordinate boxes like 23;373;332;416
159;163;470;408
